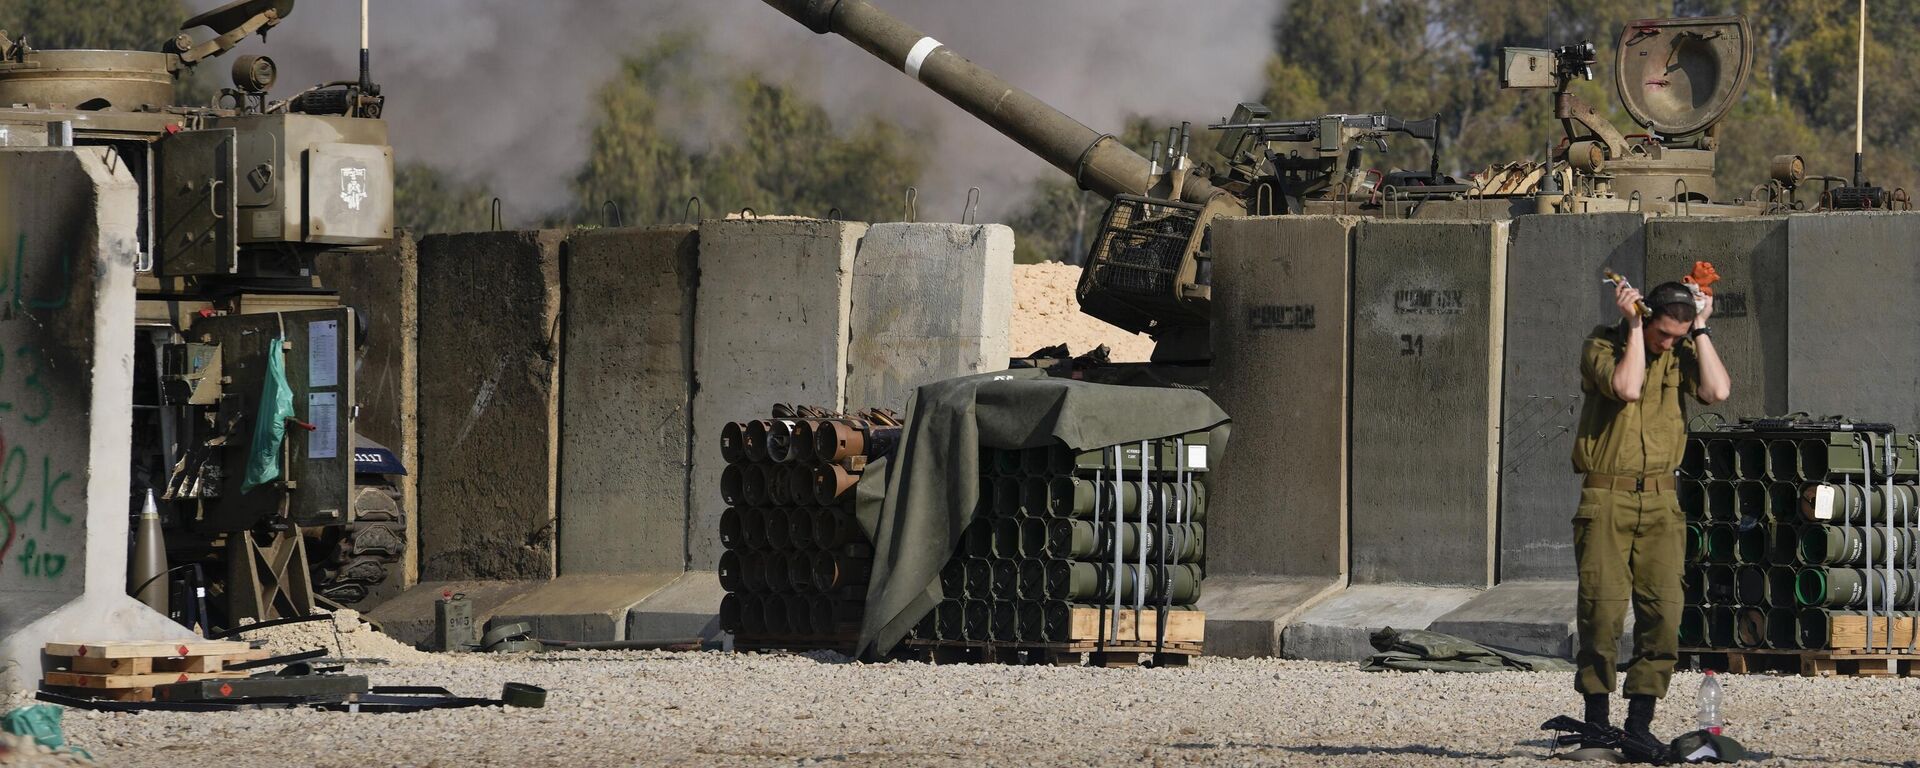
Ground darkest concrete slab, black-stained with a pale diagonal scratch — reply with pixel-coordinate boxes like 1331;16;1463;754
419;230;566;580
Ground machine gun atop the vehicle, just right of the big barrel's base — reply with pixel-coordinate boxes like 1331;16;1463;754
1210;104;1469;215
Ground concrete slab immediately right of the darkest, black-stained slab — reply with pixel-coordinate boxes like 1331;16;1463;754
559;227;699;574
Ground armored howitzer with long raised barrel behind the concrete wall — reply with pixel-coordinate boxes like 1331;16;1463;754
766;0;1903;363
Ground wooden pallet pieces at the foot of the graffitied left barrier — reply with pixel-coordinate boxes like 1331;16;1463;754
40;641;267;701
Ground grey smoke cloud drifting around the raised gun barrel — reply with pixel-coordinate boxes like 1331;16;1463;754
190;0;1281;225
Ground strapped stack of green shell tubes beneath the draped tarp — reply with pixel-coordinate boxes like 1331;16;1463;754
914;434;1208;643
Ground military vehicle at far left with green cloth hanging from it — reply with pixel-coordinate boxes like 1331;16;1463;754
0;0;405;628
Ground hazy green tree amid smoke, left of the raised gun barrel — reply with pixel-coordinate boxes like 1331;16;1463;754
574;33;927;223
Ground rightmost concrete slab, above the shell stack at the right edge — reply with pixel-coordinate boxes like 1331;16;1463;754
1781;213;1920;430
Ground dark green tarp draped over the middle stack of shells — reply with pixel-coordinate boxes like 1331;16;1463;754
854;369;1229;659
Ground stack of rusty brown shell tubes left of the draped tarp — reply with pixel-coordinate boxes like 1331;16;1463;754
718;409;900;649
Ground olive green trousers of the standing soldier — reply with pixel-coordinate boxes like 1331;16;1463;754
1572;488;1686;697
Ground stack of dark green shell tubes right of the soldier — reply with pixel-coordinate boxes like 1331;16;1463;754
1678;428;1920;653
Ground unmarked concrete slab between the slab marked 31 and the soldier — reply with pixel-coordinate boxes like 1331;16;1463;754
1500;213;1647;580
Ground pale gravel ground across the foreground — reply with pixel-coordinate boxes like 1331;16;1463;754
41;651;1920;768
